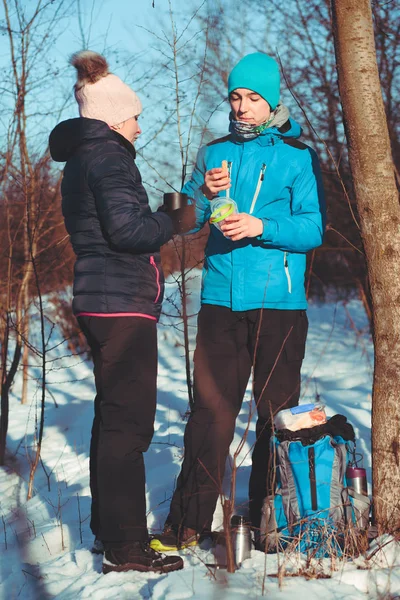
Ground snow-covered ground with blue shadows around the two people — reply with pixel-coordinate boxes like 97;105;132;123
0;282;400;600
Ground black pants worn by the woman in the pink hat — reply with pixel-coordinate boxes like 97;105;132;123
78;317;157;542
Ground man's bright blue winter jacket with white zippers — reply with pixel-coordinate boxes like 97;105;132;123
183;120;325;311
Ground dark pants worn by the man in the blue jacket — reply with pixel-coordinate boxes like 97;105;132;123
168;305;308;532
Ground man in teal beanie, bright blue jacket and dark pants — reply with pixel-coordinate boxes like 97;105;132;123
151;53;325;550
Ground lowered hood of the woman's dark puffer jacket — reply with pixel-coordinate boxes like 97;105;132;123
49;117;135;162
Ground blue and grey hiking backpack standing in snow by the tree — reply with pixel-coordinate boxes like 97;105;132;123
260;415;370;557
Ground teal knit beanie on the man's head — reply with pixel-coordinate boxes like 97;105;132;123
228;52;280;110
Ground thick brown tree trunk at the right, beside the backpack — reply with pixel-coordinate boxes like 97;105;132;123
332;0;400;531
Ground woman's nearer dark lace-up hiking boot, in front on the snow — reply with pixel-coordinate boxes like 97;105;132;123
103;542;183;575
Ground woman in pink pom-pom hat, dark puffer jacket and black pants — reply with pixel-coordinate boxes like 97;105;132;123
50;51;183;573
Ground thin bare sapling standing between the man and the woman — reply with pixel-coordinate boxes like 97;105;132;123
139;0;212;408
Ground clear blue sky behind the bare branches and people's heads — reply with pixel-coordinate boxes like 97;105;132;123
0;0;284;189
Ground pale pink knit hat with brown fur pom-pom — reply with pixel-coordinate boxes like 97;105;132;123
70;50;142;126
